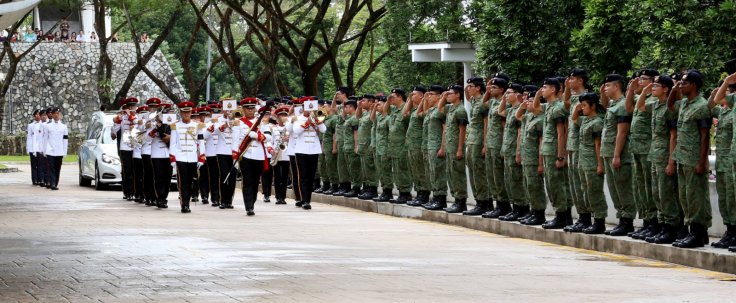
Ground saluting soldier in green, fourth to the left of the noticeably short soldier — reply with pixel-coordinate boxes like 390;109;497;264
498;83;529;221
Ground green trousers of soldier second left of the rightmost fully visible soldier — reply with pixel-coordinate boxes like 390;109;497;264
633;154;657;220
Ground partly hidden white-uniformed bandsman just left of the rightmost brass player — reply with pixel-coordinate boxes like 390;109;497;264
271;107;291;204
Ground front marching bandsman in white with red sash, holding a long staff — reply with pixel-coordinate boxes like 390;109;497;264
232;98;271;216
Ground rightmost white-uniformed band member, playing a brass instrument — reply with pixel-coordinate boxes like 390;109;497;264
291;97;327;210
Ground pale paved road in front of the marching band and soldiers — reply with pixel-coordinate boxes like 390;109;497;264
0;164;736;302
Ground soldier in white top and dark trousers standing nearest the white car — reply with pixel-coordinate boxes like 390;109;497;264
45;107;69;190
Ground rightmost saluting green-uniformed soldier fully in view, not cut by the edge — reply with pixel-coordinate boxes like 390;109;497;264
668;70;713;248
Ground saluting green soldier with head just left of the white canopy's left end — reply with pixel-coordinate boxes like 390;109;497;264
384;88;411;204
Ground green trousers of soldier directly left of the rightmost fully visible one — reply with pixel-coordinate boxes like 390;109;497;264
652;160;683;226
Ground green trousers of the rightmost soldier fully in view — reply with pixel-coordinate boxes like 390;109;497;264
677;164;713;227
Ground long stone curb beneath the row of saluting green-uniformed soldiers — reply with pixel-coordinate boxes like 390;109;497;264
298;190;736;274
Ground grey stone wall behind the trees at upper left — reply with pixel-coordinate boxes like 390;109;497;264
0;43;185;135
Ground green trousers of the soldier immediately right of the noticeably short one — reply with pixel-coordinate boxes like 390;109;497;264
603;157;636;219
